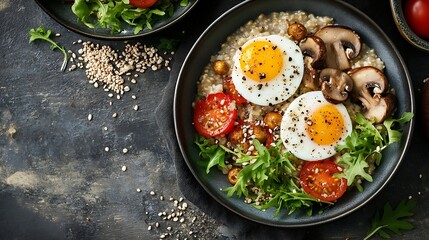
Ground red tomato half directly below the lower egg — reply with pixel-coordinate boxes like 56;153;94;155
299;160;347;202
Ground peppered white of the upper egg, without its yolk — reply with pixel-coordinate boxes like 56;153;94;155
232;35;304;106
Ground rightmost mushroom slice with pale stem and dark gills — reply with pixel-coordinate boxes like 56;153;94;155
348;66;396;123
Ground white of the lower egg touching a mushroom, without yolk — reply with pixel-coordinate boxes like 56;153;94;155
280;91;353;161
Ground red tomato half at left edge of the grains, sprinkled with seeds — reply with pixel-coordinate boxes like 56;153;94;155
194;93;237;137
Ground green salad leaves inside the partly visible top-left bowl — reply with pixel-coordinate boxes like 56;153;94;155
72;0;188;34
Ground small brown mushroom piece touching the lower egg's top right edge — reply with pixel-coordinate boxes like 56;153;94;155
320;68;353;104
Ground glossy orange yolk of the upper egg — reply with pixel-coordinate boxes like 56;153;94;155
240;41;283;82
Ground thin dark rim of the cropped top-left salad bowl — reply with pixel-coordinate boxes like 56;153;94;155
34;0;199;40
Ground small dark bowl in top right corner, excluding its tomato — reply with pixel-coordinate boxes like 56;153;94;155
390;0;429;51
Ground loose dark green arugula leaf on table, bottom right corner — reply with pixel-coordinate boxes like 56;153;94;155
364;200;416;240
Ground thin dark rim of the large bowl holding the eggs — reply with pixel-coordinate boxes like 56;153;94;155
173;0;415;228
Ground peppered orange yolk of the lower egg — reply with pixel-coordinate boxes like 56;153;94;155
306;104;344;145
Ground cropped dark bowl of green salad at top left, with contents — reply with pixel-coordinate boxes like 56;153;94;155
36;0;198;40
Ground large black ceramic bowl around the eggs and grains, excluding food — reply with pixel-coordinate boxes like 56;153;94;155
174;0;414;227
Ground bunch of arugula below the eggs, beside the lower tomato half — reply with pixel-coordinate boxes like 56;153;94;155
196;138;320;216
